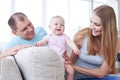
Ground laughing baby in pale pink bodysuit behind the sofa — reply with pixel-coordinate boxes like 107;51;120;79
35;16;80;80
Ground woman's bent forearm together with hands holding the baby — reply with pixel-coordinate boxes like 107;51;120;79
64;52;111;78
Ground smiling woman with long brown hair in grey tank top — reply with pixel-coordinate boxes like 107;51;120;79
64;5;120;80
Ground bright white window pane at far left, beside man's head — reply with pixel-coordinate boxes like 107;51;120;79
0;0;11;42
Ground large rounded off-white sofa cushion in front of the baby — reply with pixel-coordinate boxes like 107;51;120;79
15;47;64;80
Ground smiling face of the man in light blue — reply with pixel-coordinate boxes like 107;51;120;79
13;17;35;40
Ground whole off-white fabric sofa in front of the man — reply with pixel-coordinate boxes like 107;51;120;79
1;47;64;80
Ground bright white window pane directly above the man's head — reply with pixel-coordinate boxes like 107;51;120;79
14;0;42;27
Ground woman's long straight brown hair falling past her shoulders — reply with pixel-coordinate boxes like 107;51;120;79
88;5;118;72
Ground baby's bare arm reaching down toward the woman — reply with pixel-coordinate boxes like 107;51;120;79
66;38;80;55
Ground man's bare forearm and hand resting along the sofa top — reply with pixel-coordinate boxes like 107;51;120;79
0;45;30;60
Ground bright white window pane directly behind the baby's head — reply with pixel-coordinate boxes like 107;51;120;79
45;0;69;32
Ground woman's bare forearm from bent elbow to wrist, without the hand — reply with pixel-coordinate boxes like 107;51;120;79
73;61;110;78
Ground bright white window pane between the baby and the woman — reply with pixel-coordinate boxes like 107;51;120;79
69;0;90;37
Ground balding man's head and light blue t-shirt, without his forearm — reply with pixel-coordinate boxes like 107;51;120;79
5;12;47;49
